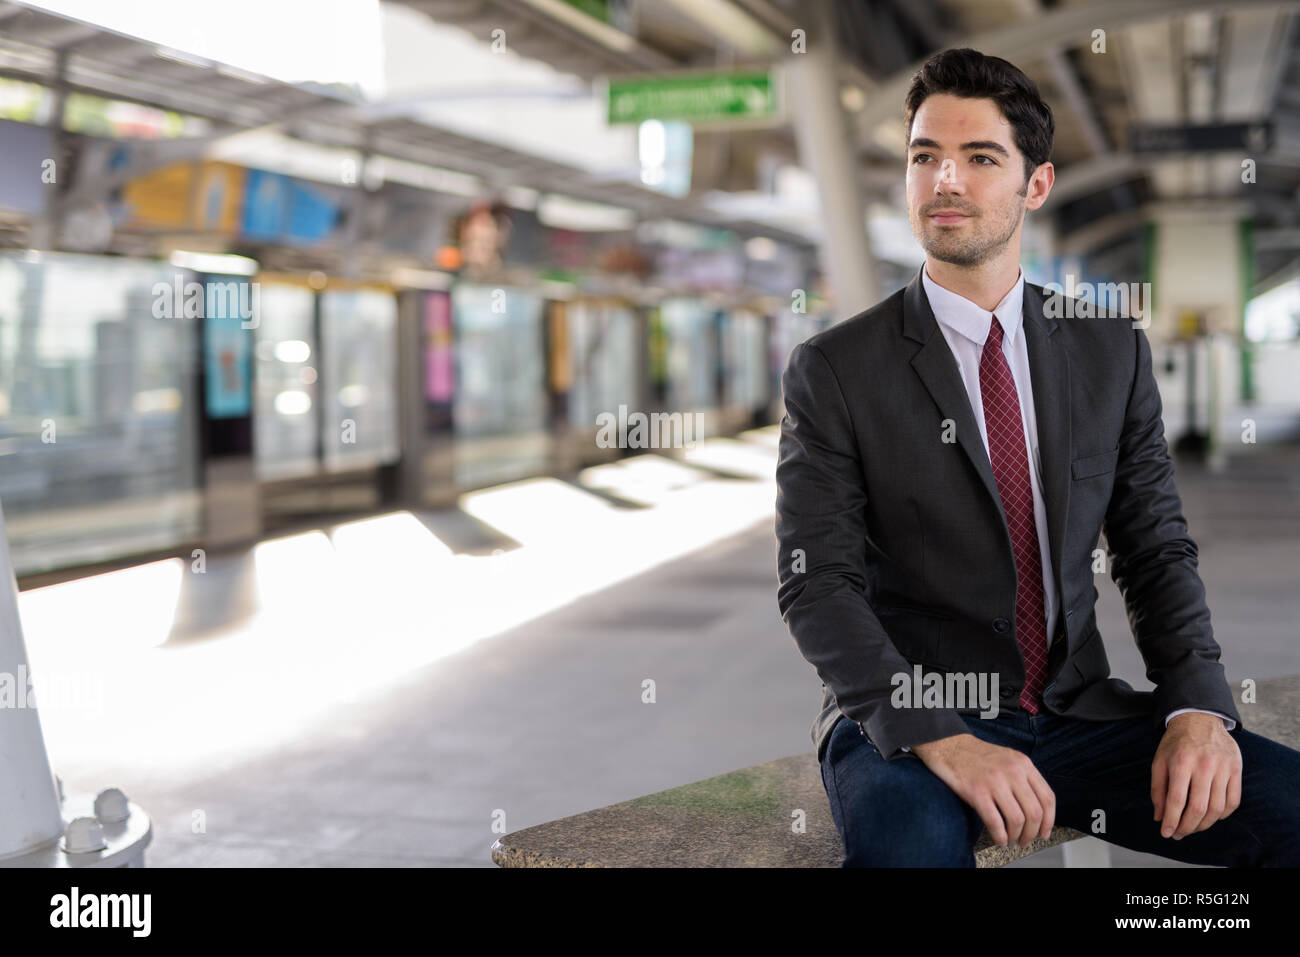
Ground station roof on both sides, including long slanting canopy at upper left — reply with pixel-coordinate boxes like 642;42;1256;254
0;0;1300;291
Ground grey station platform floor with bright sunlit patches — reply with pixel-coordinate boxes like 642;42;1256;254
20;426;1300;867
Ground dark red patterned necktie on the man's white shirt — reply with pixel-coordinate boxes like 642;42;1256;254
979;316;1048;714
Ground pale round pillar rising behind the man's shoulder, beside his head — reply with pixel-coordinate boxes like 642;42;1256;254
783;0;883;319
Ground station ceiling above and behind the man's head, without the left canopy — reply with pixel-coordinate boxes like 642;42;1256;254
398;0;1300;291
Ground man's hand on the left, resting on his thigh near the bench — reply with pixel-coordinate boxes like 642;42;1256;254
911;733;1056;848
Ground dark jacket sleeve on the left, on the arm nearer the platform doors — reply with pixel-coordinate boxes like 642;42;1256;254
776;342;969;759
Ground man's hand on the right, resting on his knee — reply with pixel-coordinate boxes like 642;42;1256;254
1151;713;1242;841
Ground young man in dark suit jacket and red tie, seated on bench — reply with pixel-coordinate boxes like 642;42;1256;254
776;49;1300;866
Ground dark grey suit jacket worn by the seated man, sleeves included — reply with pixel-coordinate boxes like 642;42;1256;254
776;270;1243;759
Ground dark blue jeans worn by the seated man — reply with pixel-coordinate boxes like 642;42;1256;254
822;709;1300;867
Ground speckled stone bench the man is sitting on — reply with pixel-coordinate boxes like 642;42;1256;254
491;676;1300;867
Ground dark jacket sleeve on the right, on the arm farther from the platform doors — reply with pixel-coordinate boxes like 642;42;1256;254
1102;328;1242;727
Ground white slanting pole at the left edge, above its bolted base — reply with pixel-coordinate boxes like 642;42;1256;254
0;508;64;858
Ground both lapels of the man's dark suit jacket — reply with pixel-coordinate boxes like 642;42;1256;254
902;269;1070;605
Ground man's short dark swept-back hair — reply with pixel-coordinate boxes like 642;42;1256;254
904;47;1056;182
